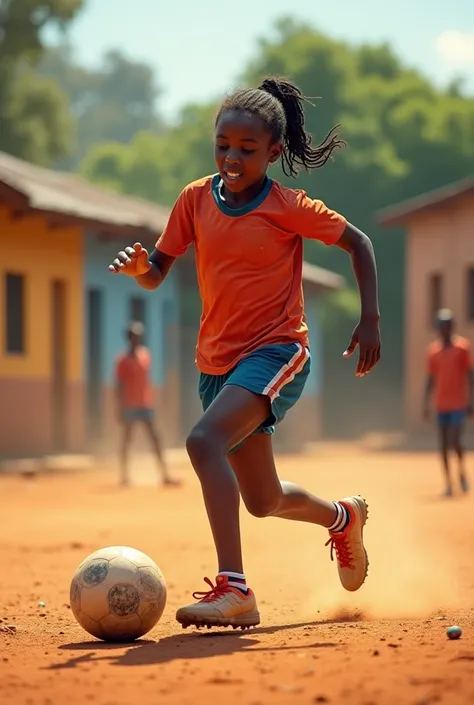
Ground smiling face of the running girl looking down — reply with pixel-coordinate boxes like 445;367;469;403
214;110;282;193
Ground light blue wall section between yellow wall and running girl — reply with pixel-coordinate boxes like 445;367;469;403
84;232;179;385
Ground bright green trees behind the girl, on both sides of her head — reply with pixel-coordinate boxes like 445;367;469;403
78;18;474;435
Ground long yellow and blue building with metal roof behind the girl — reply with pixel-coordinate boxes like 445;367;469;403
0;154;343;457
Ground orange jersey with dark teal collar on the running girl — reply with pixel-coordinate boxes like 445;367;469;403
156;175;347;375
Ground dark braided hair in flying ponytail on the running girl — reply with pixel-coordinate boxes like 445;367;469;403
216;78;345;176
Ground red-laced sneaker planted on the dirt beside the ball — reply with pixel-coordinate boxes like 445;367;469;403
176;575;260;629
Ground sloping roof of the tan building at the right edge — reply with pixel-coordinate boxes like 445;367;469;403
377;176;474;225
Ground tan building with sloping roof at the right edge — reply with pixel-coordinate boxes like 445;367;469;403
380;177;474;432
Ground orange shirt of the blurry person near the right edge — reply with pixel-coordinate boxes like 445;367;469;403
427;336;472;412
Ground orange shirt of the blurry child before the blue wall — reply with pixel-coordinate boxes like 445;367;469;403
115;346;153;409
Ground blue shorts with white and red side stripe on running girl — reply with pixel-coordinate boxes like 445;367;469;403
199;343;311;452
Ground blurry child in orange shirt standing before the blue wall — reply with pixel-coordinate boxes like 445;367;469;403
115;322;180;485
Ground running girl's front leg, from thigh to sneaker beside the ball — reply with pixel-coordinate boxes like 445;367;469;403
176;385;270;628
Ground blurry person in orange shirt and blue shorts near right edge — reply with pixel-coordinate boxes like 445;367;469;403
424;309;474;497
